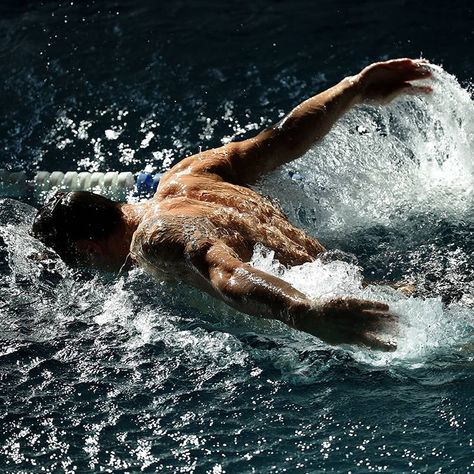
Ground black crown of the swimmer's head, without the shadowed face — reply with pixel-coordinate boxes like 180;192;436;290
31;191;122;265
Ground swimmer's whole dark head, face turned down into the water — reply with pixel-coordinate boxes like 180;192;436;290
31;191;122;269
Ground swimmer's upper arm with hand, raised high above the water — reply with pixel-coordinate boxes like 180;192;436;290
164;59;431;184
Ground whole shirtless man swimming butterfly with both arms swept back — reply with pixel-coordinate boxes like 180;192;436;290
32;59;431;350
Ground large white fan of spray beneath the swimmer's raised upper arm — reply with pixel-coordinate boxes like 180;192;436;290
264;66;474;233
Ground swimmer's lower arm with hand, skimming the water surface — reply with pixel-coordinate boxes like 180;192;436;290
199;244;394;350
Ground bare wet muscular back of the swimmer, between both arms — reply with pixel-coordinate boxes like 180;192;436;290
131;175;324;284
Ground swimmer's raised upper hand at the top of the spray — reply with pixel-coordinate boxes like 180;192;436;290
351;58;433;104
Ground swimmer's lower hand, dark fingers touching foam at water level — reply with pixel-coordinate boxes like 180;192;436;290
295;298;397;351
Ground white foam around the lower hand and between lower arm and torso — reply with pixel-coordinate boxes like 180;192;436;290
252;244;473;366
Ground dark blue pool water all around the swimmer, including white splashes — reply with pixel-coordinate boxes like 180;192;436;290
0;0;474;473
